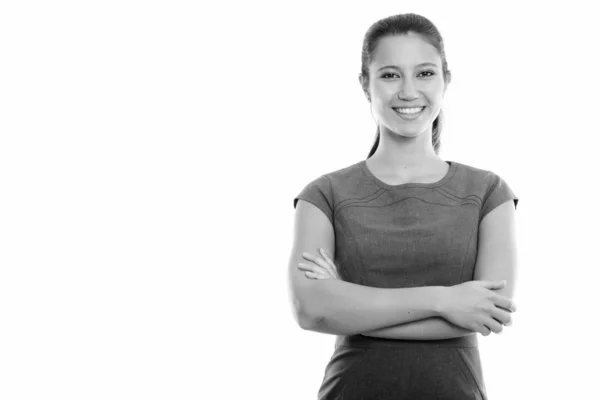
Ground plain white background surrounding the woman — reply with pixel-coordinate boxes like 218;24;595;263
0;0;600;400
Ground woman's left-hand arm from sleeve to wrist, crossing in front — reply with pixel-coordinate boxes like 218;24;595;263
288;197;443;335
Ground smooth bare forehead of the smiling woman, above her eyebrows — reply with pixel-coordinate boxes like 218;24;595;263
371;33;442;69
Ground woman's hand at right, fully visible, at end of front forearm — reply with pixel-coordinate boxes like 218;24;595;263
440;281;517;336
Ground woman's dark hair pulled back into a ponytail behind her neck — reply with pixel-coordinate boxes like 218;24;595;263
360;14;451;158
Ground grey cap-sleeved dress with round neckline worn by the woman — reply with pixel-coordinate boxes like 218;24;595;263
294;160;519;400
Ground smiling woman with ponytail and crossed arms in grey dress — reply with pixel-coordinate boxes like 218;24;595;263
289;14;518;400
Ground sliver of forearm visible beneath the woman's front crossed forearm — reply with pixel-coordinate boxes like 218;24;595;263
362;317;474;340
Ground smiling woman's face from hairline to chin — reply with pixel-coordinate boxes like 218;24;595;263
369;33;445;137
